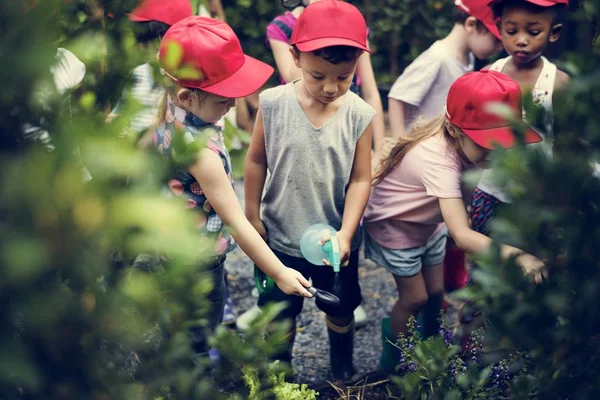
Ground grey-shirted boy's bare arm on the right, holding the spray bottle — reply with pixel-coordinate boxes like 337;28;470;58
337;123;373;261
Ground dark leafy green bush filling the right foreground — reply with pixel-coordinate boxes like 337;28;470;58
386;1;600;399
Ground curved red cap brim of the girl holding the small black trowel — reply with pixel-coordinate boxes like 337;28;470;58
180;54;275;98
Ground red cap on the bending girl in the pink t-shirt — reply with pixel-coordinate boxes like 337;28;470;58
446;70;542;149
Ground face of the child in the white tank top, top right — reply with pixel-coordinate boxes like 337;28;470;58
499;4;562;65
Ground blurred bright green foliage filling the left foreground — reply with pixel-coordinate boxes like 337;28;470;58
0;0;300;399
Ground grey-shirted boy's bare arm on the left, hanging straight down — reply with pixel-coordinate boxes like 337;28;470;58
244;107;267;239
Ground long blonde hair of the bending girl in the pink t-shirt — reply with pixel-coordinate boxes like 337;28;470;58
373;117;463;185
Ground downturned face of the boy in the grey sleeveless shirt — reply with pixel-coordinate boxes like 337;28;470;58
292;50;358;104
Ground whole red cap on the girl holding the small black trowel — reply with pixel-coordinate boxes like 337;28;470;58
159;16;273;98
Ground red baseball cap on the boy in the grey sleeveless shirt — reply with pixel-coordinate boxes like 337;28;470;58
291;0;369;52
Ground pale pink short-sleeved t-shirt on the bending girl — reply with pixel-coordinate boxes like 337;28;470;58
364;135;465;249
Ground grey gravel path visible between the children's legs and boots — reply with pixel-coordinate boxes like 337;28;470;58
226;182;397;384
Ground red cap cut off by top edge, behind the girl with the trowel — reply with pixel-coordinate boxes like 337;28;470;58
129;0;194;25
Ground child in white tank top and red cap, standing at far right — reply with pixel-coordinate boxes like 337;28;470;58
471;0;569;235
